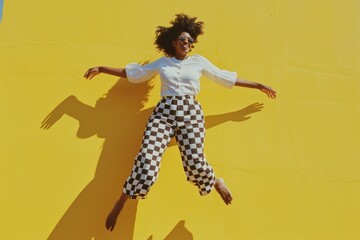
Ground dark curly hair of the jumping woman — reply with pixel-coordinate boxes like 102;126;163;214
154;14;204;57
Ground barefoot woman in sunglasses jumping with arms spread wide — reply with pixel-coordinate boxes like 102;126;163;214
84;14;276;231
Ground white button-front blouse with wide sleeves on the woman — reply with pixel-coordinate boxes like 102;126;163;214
126;55;237;97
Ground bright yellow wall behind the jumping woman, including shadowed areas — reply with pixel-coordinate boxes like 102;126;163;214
0;0;360;240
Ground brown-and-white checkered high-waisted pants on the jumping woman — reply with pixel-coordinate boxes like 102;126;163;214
123;96;215;199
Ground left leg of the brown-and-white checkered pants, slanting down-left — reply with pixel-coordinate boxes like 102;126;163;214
123;102;174;199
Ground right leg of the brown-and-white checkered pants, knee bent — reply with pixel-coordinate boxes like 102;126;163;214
175;99;215;196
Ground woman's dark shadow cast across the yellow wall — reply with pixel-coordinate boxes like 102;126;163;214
41;79;263;240
